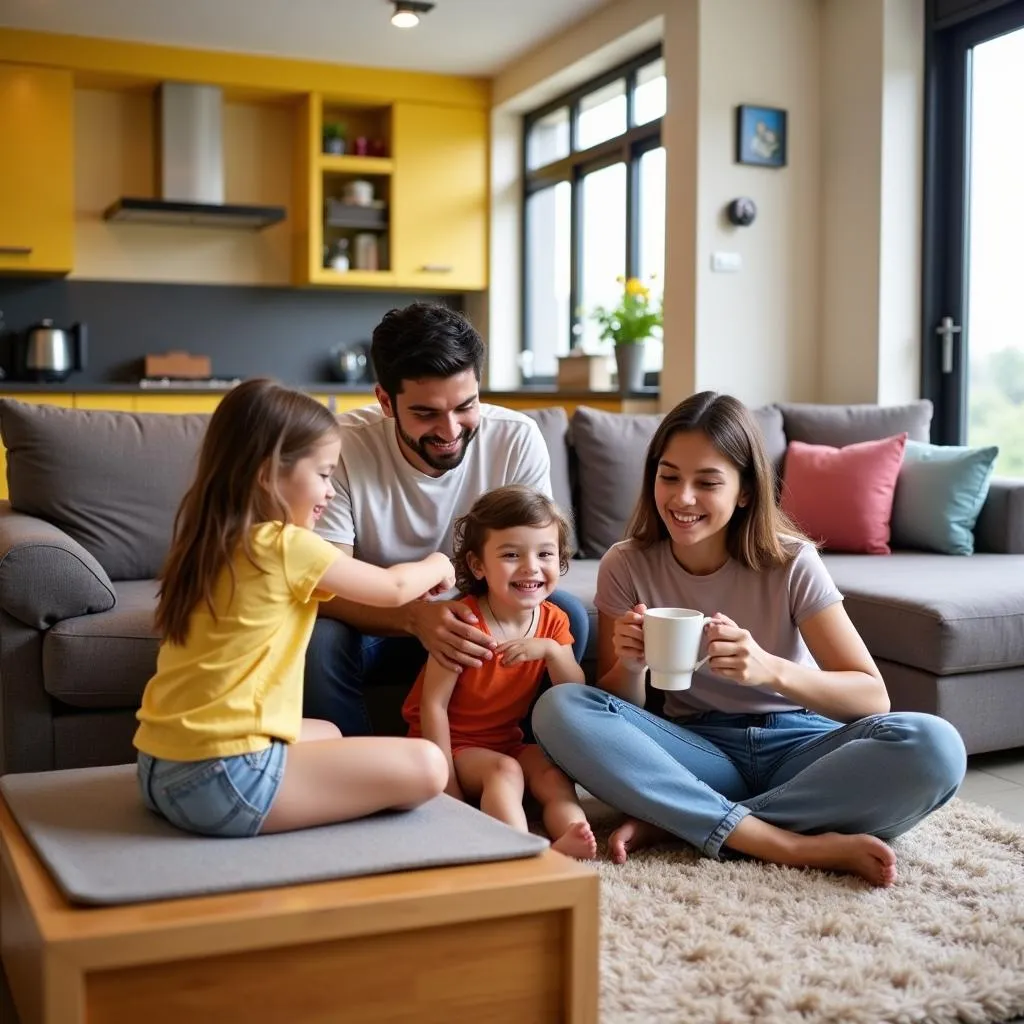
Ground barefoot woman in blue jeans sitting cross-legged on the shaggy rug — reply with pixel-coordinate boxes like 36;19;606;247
532;391;966;886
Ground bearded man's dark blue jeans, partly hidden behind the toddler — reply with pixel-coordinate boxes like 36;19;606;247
303;590;590;736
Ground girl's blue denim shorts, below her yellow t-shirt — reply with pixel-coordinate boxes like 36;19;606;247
138;739;288;837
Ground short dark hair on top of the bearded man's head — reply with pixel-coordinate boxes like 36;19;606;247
370;302;483;400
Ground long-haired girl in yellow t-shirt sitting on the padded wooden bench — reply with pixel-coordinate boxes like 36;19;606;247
135;380;455;836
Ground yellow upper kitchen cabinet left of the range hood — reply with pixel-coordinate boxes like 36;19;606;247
0;63;75;275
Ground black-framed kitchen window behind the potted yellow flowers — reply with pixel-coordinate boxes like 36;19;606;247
522;47;666;383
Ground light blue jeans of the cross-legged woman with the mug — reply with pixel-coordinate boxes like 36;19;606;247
534;685;967;857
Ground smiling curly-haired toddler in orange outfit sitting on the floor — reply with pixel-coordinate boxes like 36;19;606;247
402;485;597;859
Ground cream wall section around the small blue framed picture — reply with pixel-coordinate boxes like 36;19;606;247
684;0;821;406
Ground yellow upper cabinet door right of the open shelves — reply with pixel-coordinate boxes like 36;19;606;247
391;102;487;291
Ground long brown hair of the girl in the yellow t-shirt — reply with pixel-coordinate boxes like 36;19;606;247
156;379;338;644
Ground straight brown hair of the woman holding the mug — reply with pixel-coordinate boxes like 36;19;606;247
627;391;806;571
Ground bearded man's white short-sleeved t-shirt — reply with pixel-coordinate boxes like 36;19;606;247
316;404;551;567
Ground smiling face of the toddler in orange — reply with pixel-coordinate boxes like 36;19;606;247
466;522;559;609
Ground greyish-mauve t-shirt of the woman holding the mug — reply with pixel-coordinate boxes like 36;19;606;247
594;541;843;718
